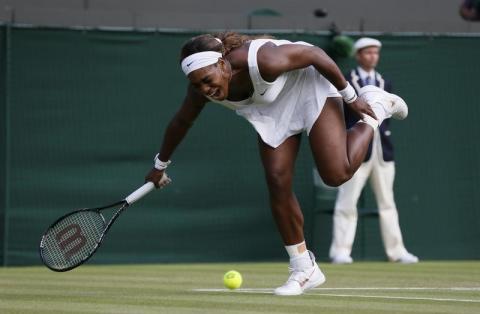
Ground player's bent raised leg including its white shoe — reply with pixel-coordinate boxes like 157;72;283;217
309;86;408;186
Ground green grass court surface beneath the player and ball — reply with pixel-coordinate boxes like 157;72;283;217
0;261;480;314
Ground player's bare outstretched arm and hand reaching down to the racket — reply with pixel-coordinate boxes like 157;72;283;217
145;84;208;187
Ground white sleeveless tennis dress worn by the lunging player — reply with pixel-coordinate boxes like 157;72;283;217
210;39;341;148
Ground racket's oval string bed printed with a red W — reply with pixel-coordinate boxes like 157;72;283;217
41;211;106;270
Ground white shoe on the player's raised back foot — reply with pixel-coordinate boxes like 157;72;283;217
359;85;408;123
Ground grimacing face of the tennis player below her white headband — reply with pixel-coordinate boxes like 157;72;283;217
188;60;230;100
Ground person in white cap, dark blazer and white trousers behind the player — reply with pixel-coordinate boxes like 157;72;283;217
330;38;418;264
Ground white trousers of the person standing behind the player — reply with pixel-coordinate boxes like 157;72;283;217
330;149;407;261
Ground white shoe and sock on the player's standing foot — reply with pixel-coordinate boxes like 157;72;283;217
274;251;325;295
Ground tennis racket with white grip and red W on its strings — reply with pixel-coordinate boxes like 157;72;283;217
40;174;170;271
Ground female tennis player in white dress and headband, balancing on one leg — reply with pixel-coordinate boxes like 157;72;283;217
146;32;408;295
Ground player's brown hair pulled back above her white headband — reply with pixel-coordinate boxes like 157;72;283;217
180;32;273;62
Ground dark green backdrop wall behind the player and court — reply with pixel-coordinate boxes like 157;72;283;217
0;27;480;265
